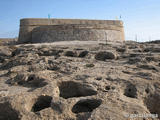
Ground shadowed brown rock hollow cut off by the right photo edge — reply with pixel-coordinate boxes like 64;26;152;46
145;93;160;118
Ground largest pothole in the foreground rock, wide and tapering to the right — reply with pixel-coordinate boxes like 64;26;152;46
59;81;97;99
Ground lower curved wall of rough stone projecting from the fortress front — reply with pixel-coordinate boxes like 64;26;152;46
31;25;123;43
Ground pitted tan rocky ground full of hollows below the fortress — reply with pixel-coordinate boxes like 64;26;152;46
0;42;160;120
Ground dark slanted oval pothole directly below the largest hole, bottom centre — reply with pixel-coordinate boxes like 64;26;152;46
72;99;102;114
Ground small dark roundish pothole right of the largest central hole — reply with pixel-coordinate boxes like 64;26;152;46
124;84;137;98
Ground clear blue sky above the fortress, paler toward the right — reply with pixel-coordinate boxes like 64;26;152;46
0;0;160;41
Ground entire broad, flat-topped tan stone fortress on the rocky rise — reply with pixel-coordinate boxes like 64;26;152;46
18;18;125;43
